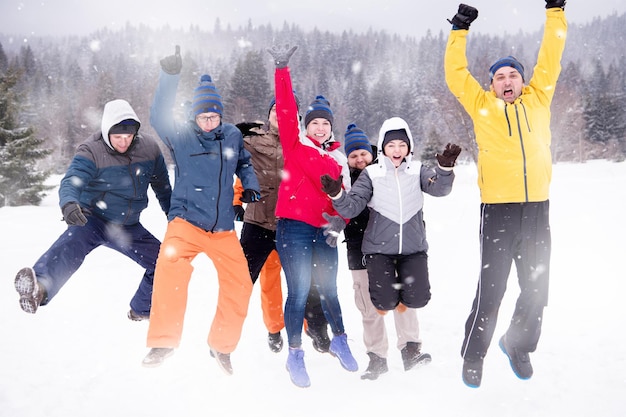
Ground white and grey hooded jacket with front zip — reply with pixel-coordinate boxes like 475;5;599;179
333;117;454;255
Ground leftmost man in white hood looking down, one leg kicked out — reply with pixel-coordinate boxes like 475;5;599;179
15;100;172;321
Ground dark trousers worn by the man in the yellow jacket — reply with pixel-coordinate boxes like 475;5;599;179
461;201;551;361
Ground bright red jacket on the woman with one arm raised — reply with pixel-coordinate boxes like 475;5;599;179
274;68;350;227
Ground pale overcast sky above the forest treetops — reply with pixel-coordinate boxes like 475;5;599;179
0;0;626;37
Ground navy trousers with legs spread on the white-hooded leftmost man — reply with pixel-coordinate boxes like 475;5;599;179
33;216;161;315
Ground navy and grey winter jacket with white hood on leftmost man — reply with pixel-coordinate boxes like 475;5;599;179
59;100;172;225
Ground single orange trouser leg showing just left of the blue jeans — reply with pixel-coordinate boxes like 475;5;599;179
259;250;285;333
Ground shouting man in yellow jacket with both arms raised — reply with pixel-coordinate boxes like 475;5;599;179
444;0;567;388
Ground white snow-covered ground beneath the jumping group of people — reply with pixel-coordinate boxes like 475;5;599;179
0;161;626;417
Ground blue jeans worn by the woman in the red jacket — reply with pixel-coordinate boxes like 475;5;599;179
276;219;345;348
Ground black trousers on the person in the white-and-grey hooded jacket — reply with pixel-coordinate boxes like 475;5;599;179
365;252;430;310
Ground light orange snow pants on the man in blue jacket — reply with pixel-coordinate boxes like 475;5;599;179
147;218;252;353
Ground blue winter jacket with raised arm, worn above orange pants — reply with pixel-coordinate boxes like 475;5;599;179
150;71;260;232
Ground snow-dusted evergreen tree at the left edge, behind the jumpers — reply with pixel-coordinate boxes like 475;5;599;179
0;69;52;207
